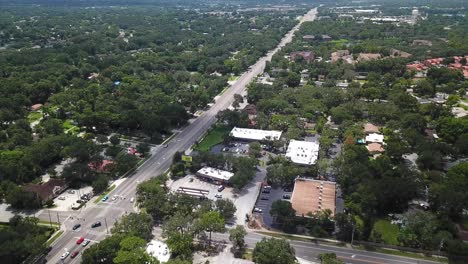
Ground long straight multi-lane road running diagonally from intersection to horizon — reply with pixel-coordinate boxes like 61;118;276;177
43;9;316;263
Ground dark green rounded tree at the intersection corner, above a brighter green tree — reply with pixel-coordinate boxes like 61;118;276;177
111;213;153;241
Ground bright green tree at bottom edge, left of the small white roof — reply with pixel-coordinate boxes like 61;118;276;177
114;236;159;264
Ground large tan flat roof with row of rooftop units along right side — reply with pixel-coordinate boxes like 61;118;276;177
291;178;336;216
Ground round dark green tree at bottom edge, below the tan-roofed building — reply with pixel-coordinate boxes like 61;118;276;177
252;238;297;264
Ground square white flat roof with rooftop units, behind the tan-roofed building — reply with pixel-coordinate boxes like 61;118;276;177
286;140;319;165
